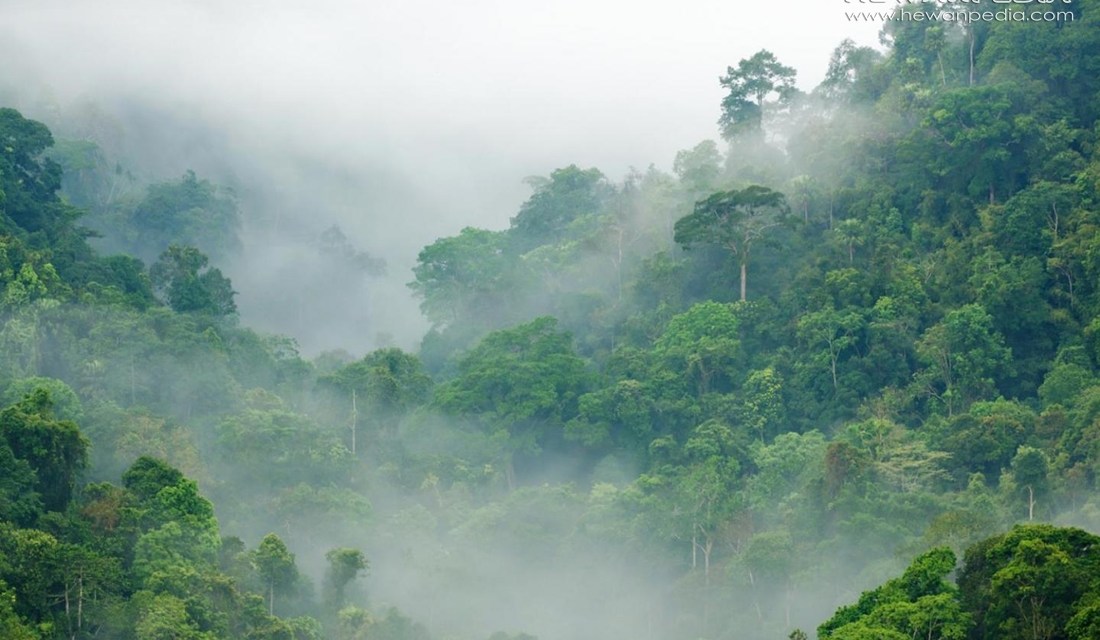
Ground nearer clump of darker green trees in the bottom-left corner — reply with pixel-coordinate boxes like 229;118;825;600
0;391;321;640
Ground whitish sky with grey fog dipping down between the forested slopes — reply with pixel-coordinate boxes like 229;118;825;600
0;0;880;351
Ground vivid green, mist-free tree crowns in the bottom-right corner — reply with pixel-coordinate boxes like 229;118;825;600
817;525;1100;640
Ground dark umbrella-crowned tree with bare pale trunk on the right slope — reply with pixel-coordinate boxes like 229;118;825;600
674;185;789;301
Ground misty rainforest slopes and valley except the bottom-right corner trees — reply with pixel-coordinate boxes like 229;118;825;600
0;0;1100;640
